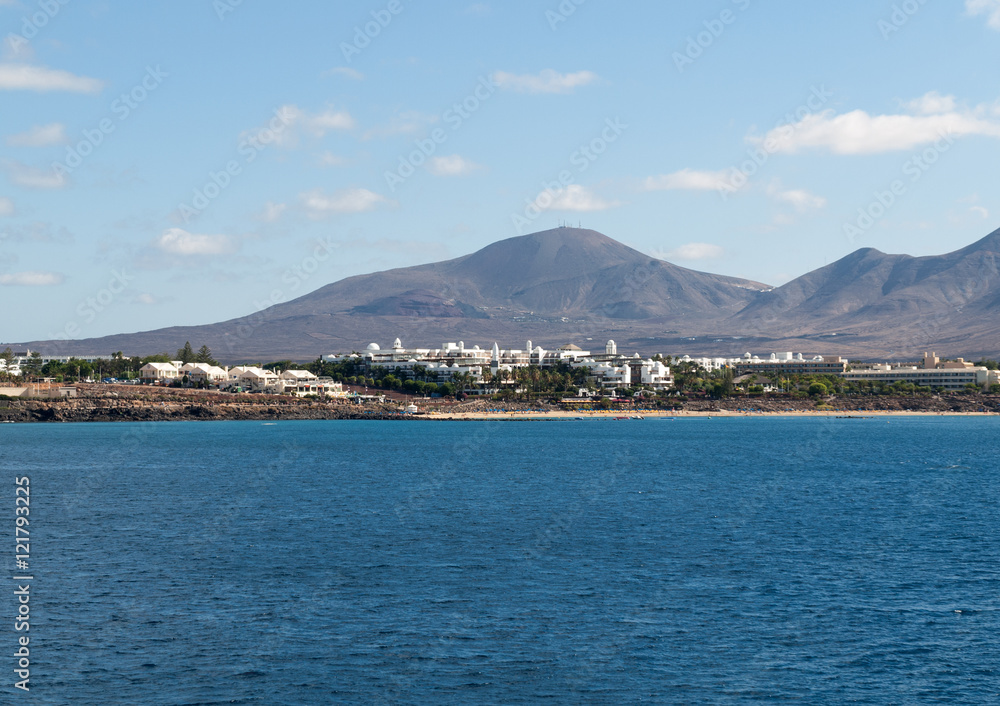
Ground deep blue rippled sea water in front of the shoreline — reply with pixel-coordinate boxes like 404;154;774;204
0;417;1000;704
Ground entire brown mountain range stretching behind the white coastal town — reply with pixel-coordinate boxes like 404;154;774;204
13;228;1000;361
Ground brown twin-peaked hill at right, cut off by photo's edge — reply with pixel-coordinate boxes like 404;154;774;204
723;230;1000;355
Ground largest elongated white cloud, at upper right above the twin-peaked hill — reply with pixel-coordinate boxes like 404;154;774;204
750;92;1000;154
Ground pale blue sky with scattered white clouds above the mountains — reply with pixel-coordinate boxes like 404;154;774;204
0;0;1000;340
